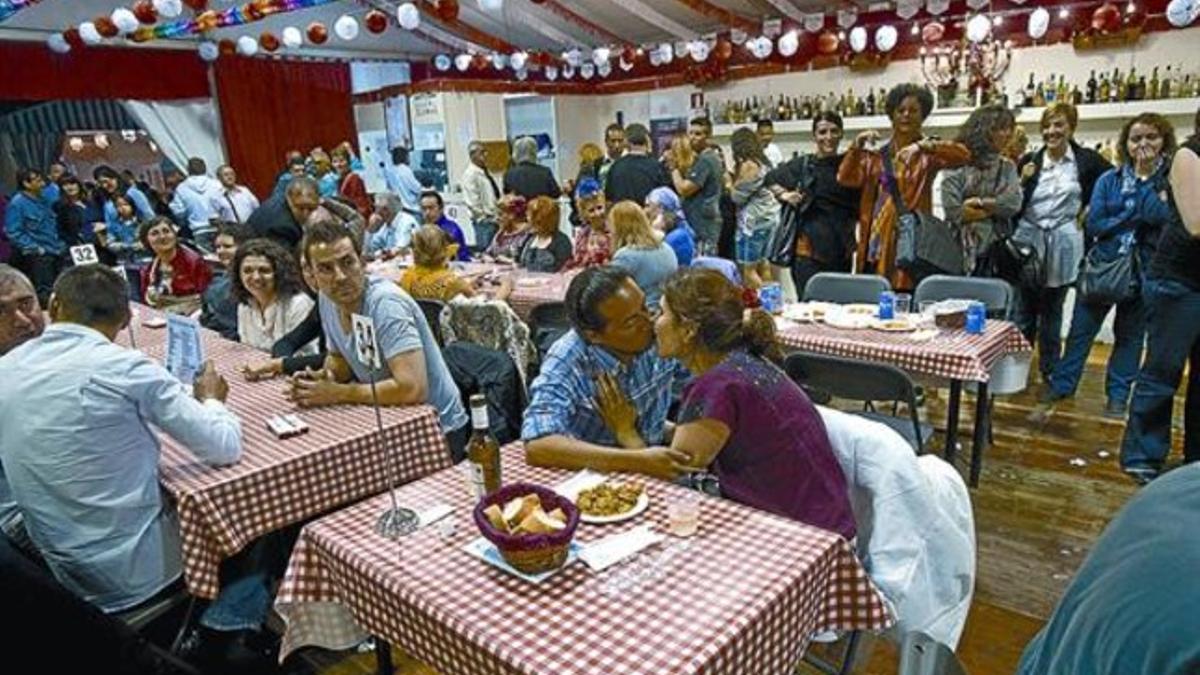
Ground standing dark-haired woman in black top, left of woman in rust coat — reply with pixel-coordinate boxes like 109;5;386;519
766;110;859;297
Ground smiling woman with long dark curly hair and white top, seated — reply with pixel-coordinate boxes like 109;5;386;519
232;239;314;352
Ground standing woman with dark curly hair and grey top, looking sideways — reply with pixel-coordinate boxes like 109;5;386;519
942;104;1022;270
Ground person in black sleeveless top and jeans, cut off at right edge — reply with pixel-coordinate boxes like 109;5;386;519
1121;110;1200;483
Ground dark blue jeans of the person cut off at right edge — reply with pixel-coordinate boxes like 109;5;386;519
1121;279;1200;470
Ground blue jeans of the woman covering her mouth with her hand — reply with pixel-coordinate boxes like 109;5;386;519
1050;294;1146;405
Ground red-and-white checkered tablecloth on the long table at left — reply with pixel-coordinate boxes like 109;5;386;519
119;307;450;598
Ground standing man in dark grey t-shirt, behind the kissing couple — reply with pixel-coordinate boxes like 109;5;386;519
671;118;725;255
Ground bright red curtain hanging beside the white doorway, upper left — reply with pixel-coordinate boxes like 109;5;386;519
216;55;358;198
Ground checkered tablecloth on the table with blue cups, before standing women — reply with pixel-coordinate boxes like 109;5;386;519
776;319;1031;382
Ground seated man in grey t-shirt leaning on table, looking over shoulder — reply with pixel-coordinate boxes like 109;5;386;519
292;219;469;460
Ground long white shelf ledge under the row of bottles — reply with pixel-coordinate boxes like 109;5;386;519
713;97;1200;138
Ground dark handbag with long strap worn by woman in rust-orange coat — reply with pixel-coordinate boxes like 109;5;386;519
883;148;965;279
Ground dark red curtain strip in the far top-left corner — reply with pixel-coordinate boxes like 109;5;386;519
0;41;209;101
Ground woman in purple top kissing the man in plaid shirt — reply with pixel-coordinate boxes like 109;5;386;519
654;269;854;539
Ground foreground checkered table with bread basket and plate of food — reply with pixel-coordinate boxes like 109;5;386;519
276;443;892;675
